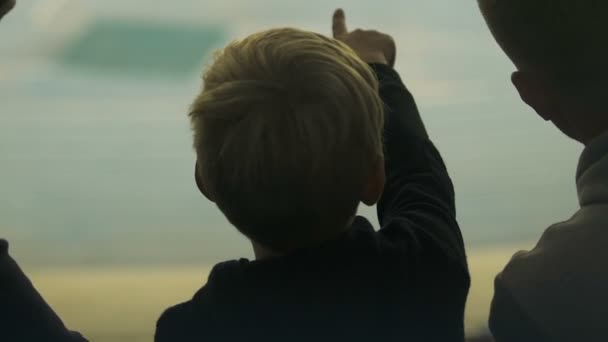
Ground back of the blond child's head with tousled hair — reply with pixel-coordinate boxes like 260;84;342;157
190;28;384;252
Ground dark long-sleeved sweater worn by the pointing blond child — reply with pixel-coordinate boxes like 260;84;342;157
156;64;470;342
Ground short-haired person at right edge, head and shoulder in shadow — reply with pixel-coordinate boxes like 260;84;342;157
479;0;608;342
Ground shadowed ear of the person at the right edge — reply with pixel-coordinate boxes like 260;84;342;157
511;71;556;121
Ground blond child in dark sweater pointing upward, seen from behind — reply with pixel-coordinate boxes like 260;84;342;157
156;11;469;342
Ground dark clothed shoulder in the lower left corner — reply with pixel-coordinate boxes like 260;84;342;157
0;239;86;342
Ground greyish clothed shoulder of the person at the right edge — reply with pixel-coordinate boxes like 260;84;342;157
491;210;608;340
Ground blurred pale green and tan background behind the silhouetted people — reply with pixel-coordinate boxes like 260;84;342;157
0;0;581;341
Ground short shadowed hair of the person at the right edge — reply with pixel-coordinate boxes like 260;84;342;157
478;0;608;81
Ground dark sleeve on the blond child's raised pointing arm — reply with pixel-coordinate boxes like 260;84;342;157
372;64;469;272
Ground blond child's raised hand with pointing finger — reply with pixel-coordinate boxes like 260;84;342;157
333;9;397;66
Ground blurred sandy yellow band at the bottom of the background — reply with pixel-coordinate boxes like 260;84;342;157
26;244;532;342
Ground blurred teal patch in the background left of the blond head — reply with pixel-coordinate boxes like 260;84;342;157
61;19;225;78
